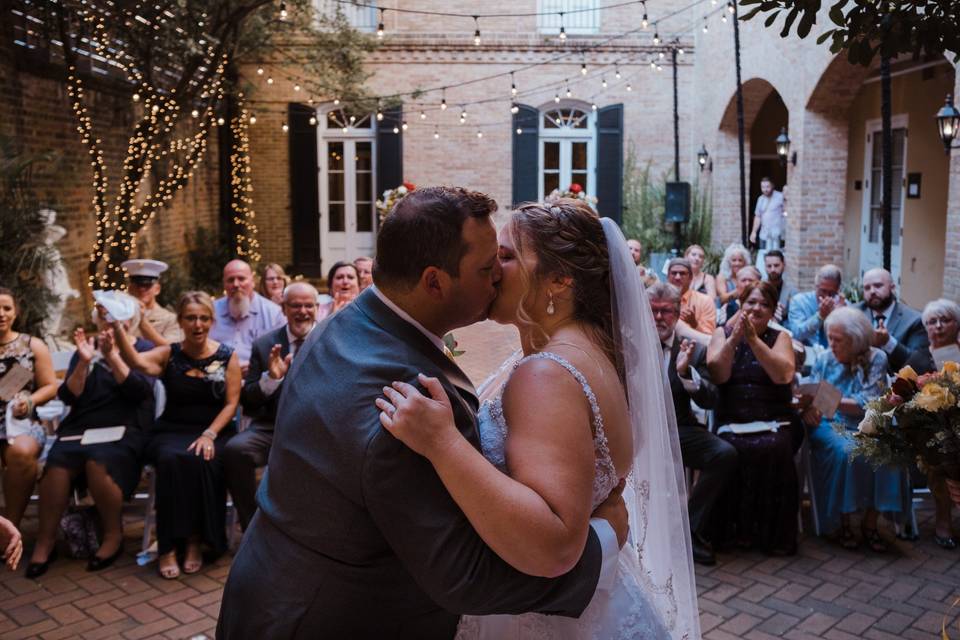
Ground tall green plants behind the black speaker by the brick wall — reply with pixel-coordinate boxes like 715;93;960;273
620;144;719;262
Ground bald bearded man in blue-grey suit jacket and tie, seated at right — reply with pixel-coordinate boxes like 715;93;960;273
857;269;930;373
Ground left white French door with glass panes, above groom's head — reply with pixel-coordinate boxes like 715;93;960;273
320;138;376;268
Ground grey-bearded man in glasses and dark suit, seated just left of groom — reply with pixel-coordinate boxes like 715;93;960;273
223;282;317;530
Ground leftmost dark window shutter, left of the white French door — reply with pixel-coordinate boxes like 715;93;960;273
287;104;322;277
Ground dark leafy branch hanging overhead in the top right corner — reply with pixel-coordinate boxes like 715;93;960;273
740;0;960;66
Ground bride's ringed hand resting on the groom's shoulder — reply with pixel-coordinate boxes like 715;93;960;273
375;373;460;459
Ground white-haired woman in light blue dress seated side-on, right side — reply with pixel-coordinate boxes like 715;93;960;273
803;307;907;553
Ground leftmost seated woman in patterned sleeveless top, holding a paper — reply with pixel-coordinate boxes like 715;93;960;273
0;287;57;527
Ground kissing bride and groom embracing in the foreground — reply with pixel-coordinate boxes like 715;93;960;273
217;187;700;640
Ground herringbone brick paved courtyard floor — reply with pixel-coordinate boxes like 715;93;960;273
0;324;960;640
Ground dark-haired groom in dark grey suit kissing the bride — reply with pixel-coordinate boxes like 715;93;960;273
217;187;627;640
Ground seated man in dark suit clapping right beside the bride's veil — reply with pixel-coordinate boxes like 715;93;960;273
647;282;743;565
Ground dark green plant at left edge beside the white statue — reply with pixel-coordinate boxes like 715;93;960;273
0;137;58;335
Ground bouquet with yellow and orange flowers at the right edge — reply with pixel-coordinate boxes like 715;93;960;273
854;362;960;480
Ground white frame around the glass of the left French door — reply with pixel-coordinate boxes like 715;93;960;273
316;104;378;264
